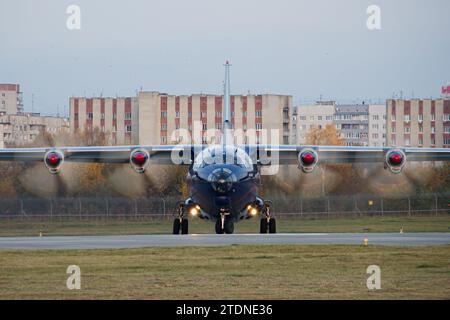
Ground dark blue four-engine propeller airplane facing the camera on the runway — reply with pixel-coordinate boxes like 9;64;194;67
0;61;450;234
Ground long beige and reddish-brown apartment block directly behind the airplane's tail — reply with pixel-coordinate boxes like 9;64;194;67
70;92;292;145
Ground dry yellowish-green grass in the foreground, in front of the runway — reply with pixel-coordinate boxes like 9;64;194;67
0;245;450;299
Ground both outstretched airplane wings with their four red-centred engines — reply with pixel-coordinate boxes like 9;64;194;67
0;145;450;174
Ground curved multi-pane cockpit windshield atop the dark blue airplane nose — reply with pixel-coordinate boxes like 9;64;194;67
193;146;253;171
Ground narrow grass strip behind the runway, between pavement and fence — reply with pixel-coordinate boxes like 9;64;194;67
0;214;450;236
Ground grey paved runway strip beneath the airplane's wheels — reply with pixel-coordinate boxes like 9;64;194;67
0;233;450;250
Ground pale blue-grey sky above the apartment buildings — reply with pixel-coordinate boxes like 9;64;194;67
0;0;450;114
